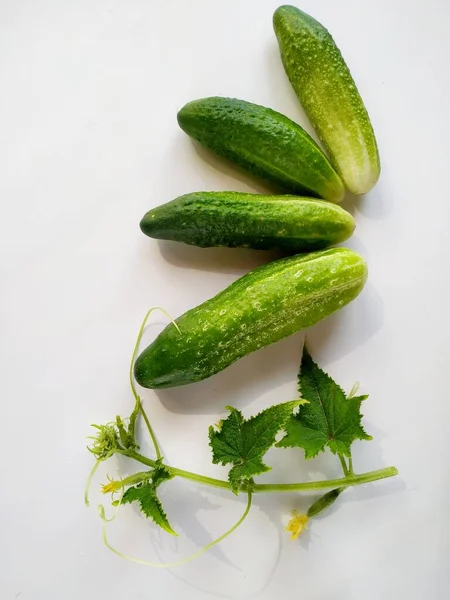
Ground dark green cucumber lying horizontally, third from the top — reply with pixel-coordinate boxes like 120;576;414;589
140;192;355;252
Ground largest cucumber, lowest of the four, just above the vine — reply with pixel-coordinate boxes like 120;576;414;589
134;248;367;388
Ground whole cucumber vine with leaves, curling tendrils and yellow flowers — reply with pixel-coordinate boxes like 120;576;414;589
85;307;397;568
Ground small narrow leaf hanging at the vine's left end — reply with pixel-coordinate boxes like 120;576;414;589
122;466;178;535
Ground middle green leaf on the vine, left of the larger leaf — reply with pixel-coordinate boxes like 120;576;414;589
209;400;302;494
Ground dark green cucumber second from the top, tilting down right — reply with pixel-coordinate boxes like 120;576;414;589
178;97;345;202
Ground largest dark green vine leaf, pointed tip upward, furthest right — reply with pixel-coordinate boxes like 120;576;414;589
277;345;372;459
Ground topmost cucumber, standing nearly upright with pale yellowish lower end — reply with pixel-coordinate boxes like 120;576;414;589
273;6;380;194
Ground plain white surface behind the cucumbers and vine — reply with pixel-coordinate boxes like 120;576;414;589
0;0;450;600
